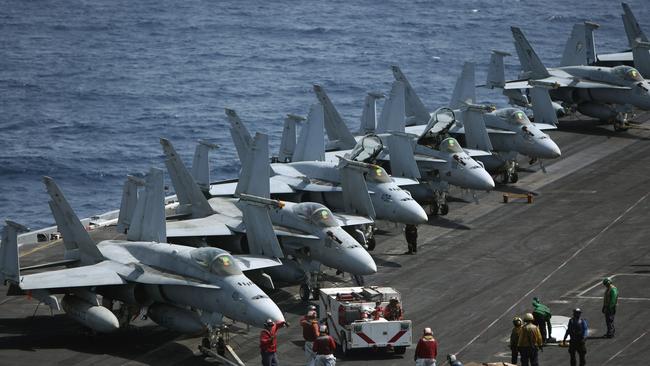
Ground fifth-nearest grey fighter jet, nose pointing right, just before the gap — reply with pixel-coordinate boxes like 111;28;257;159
442;62;560;183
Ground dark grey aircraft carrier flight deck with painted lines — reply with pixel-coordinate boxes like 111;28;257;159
0;115;650;366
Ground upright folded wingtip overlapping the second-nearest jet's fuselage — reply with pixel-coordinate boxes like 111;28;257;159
238;194;284;258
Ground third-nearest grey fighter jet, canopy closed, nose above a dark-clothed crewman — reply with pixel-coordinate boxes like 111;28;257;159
210;104;428;229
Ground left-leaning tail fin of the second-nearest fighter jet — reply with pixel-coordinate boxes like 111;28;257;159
160;138;214;218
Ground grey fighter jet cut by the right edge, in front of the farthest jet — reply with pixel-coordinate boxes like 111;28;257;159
498;27;650;130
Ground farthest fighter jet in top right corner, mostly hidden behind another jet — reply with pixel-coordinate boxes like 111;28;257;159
561;3;650;77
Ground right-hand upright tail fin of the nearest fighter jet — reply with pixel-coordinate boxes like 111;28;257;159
126;168;167;243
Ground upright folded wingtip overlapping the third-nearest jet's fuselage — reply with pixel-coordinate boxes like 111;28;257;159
339;157;381;219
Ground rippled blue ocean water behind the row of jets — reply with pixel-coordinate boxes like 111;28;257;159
0;0;650;228
